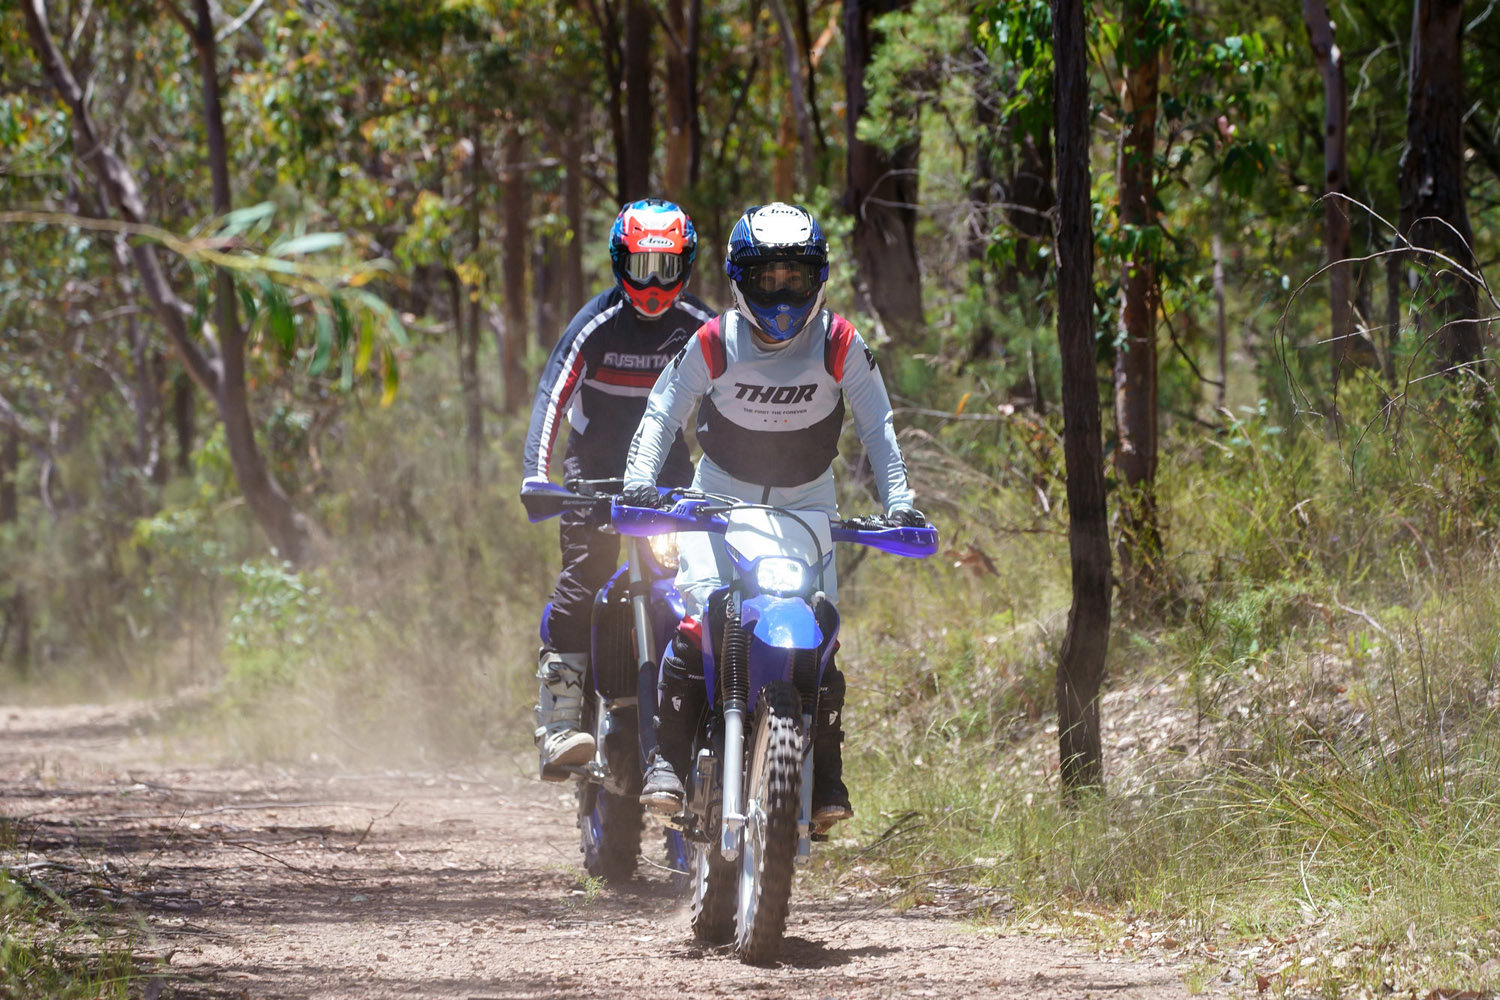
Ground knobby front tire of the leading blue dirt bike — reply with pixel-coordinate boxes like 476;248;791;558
735;682;803;966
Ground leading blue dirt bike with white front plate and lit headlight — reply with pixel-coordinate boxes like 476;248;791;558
611;490;938;964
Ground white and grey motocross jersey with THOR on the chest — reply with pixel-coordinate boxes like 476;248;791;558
626;309;912;511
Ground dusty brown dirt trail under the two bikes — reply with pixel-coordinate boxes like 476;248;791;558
0;706;1230;1000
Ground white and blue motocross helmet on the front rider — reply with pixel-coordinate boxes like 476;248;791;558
725;201;828;340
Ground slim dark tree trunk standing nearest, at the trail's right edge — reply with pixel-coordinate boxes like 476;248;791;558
1052;0;1110;796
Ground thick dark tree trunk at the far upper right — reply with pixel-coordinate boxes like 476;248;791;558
1401;0;1481;364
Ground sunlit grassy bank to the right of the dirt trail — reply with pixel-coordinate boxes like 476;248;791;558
842;379;1500;996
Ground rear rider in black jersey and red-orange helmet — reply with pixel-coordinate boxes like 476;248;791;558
522;198;713;781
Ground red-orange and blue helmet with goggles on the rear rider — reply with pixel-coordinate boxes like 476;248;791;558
609;198;698;319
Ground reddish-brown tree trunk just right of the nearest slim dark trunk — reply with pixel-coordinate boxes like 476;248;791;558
1115;0;1161;594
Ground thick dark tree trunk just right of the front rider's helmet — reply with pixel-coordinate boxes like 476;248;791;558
843;0;923;342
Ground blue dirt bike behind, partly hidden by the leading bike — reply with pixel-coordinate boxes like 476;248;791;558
522;480;690;882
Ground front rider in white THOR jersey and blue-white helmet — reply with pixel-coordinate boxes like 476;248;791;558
624;202;927;829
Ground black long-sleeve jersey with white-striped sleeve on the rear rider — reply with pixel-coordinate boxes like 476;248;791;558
525;286;714;478
